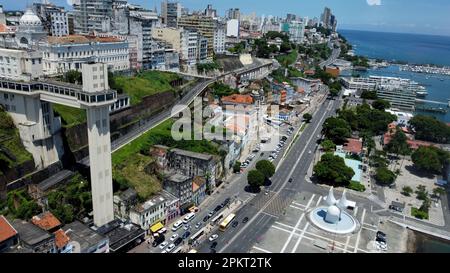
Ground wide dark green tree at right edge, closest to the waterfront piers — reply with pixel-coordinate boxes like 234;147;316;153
409;115;450;144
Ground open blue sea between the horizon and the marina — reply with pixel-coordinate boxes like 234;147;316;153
339;30;450;66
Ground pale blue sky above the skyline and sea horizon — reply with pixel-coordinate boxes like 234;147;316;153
1;0;450;36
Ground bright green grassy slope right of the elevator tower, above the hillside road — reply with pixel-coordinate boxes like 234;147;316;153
110;71;180;105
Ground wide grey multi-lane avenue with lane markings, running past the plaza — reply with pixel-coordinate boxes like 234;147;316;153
192;96;338;253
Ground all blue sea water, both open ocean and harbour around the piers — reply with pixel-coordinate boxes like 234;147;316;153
340;30;450;122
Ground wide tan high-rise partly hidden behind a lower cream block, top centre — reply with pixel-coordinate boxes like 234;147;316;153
178;14;215;60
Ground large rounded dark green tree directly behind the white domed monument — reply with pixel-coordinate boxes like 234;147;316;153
314;153;355;186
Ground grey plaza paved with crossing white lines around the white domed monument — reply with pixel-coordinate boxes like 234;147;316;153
251;190;407;253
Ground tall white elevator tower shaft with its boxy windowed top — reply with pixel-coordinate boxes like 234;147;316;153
82;63;114;227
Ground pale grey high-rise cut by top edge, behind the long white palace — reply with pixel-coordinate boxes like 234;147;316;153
73;0;114;34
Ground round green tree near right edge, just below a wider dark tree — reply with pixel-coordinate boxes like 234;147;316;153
411;147;448;174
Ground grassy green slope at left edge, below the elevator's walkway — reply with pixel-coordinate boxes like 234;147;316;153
0;108;33;174
